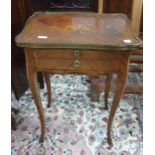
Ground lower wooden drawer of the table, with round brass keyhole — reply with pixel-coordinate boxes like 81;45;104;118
36;58;118;71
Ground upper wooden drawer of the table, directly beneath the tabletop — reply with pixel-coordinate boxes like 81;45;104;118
35;49;121;60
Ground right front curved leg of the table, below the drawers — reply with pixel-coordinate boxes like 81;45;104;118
107;73;127;145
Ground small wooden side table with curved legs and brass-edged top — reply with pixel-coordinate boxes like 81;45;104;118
16;12;141;144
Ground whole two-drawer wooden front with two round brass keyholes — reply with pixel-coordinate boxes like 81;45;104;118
34;49;121;71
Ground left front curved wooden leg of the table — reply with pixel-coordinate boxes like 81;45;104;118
25;51;45;142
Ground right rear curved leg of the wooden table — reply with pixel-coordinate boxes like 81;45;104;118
104;73;112;110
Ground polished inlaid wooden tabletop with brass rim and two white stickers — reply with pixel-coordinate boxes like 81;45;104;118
16;12;141;49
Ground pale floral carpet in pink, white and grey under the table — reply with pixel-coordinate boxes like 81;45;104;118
11;73;143;155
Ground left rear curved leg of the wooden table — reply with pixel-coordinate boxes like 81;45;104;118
44;72;52;108
